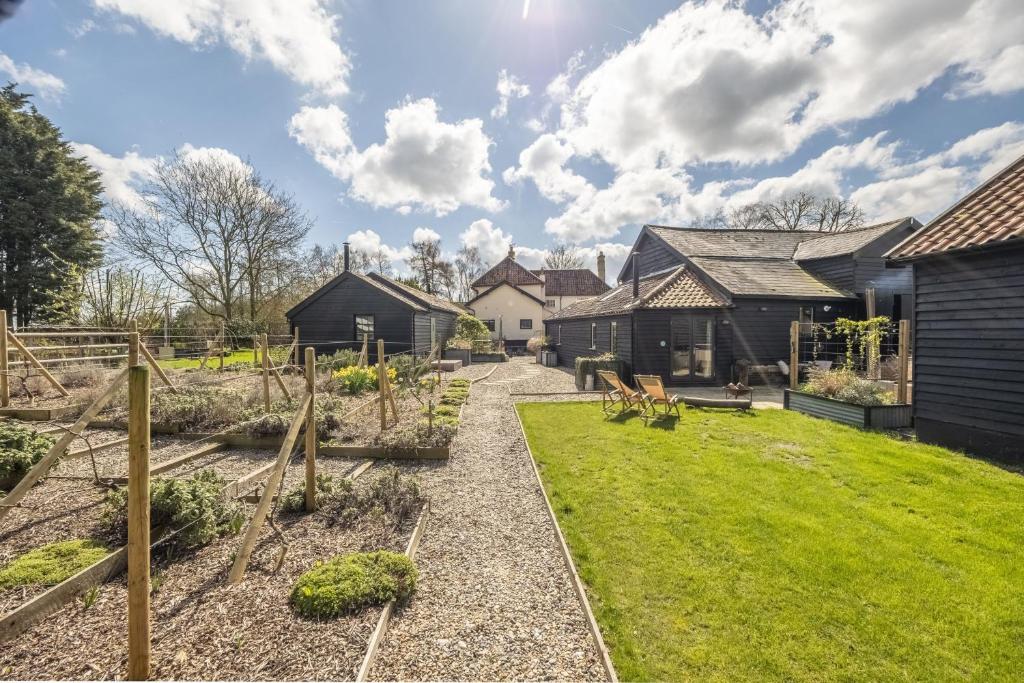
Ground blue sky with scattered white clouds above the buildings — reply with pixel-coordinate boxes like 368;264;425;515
0;0;1024;276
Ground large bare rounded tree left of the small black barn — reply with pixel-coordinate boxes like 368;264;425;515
108;151;309;321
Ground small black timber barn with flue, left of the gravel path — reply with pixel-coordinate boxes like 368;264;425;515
285;245;465;362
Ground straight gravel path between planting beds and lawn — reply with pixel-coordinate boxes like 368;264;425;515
371;360;605;680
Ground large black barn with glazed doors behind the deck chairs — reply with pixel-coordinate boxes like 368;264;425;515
545;218;921;386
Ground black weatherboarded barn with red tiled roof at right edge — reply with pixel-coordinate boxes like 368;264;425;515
889;157;1024;462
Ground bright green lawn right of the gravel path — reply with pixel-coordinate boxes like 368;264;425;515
517;403;1024;681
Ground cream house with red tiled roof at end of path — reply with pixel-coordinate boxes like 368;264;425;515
466;247;609;347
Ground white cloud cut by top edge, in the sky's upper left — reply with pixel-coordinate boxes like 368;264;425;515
93;0;351;95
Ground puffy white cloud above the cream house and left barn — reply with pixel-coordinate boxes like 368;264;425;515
289;98;505;216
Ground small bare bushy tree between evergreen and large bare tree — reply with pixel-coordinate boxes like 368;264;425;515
80;267;169;330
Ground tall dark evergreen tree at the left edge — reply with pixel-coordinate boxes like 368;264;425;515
0;84;102;326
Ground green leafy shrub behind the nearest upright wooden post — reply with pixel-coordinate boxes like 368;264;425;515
102;470;243;548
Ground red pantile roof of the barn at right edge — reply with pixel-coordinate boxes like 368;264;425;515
888;152;1024;258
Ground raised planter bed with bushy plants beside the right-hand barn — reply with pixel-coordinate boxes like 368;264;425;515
783;368;913;429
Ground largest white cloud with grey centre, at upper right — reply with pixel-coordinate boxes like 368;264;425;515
553;0;1024;170
